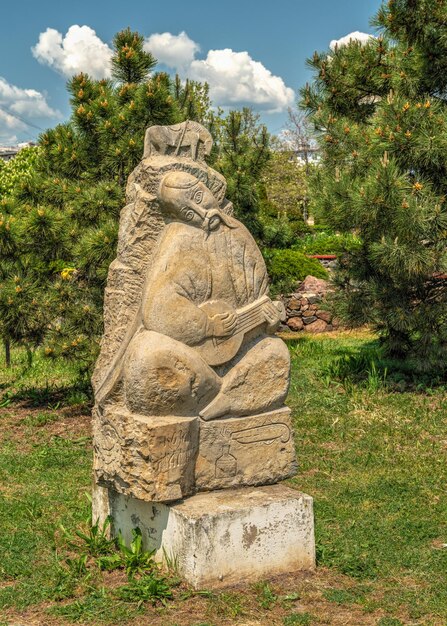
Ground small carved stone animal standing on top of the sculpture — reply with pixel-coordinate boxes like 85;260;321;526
143;120;213;161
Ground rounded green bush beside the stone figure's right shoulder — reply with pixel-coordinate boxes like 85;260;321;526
265;250;328;294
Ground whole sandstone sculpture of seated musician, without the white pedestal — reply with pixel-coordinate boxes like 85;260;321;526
93;122;295;502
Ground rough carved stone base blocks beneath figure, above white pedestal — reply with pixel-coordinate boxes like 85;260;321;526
94;407;297;502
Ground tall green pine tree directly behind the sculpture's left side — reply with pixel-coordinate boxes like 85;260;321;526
10;29;206;371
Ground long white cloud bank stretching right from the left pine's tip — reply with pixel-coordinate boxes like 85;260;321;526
145;31;295;112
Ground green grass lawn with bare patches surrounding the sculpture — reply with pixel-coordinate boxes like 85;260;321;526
0;332;447;626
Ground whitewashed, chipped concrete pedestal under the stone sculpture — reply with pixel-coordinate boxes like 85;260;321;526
93;485;315;588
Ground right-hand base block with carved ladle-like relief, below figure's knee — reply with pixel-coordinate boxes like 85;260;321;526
195;407;297;491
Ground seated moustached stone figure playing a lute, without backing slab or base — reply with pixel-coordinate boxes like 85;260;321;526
123;170;290;420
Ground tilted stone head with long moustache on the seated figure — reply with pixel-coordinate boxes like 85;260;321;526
157;170;234;233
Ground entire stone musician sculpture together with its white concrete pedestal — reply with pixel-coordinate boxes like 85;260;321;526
92;121;315;586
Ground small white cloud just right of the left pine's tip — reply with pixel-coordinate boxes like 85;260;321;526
144;31;200;70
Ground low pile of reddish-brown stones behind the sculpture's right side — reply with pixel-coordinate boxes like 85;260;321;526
282;276;339;333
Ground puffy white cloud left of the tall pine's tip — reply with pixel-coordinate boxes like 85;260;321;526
31;24;112;79
